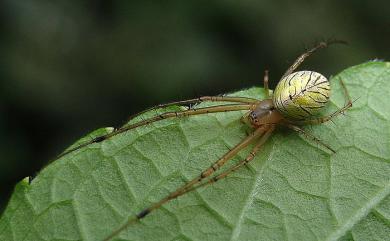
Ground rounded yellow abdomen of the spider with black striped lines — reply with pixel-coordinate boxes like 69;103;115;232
273;71;330;120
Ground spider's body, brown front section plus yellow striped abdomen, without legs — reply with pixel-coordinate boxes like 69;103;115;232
244;71;330;128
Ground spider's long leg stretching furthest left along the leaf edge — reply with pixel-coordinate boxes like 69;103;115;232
57;104;254;158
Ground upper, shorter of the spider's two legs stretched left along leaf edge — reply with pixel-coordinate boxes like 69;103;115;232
128;96;259;121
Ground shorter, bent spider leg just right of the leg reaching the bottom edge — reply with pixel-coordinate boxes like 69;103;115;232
182;125;275;194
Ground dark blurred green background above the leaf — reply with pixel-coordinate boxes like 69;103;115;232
0;0;390;212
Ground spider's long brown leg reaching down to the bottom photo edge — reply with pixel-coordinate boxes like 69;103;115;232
104;126;269;241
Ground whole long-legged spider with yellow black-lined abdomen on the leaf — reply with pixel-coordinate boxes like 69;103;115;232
59;40;352;241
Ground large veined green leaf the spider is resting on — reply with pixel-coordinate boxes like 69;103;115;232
0;62;390;241
